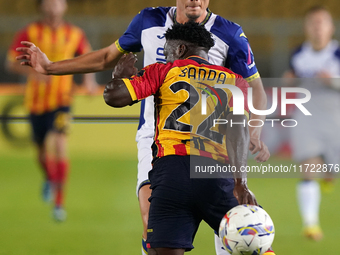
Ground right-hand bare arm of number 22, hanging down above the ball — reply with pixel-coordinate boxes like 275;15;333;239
226;113;257;205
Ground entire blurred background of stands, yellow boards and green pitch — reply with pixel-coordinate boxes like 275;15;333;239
0;0;340;255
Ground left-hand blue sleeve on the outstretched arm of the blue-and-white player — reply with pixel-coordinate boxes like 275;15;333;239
115;10;144;53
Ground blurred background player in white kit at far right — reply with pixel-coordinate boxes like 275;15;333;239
284;6;340;241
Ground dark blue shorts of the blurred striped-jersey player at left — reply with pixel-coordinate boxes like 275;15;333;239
30;107;71;145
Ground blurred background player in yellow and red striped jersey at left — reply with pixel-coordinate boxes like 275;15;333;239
7;0;96;220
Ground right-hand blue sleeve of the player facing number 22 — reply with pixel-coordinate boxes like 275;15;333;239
227;27;260;82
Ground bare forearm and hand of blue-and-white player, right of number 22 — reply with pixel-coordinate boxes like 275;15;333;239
249;78;270;162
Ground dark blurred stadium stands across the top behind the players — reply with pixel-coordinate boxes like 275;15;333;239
0;0;340;83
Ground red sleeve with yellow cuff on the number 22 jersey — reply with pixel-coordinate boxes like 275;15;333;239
122;63;168;101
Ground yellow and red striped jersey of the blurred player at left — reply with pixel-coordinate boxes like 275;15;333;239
7;21;91;114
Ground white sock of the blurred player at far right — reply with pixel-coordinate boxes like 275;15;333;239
297;180;321;226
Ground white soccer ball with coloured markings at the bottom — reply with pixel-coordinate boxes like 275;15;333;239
219;205;275;255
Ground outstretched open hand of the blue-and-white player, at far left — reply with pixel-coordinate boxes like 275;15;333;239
16;41;52;74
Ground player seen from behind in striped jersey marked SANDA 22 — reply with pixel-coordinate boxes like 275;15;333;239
104;22;274;255
